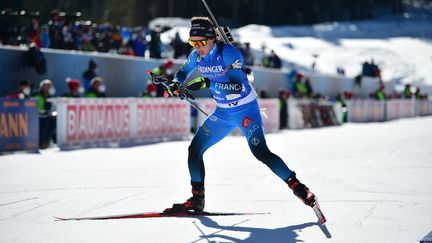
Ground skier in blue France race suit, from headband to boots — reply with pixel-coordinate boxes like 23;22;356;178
166;17;316;212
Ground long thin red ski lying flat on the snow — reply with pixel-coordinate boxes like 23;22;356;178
54;212;269;221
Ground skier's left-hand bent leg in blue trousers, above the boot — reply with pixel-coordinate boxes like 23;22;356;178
188;109;234;185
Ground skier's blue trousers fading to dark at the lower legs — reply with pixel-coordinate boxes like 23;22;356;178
188;101;292;184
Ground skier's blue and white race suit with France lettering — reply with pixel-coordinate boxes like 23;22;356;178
174;44;292;183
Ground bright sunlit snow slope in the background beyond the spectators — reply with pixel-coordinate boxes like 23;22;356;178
159;17;432;85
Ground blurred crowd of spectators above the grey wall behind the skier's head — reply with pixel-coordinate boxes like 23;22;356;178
0;10;290;69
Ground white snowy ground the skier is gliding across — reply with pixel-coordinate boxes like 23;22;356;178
0;117;432;243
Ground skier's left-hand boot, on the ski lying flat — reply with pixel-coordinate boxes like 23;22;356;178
164;185;205;214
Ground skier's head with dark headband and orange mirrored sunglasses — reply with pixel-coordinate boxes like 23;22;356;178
189;17;216;57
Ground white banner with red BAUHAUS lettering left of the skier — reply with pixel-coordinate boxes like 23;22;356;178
55;98;190;150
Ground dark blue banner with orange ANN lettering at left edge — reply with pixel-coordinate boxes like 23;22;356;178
0;99;39;153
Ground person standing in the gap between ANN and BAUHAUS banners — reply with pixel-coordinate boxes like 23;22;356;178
33;79;56;149
